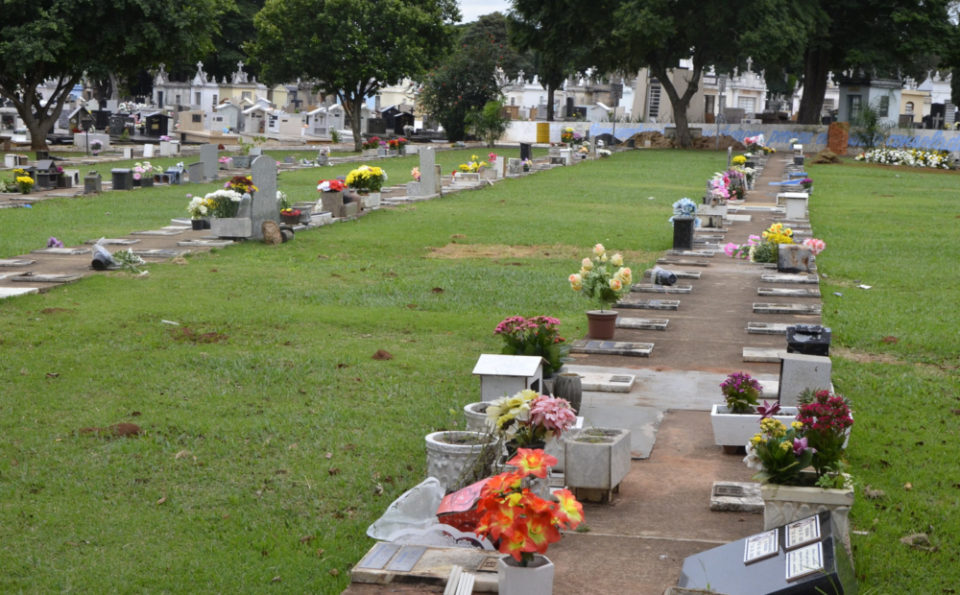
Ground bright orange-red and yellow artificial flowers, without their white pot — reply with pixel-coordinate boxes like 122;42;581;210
475;448;583;566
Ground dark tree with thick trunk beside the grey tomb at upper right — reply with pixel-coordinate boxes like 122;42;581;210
797;0;956;124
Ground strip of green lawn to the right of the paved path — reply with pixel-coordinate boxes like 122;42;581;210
807;164;960;593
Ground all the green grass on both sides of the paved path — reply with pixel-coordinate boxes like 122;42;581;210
0;151;960;593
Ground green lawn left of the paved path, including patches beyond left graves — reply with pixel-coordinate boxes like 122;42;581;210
0;151;704;593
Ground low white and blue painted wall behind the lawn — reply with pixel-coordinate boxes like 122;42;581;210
503;121;960;153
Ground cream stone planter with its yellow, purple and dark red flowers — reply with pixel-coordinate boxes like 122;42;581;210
744;390;854;548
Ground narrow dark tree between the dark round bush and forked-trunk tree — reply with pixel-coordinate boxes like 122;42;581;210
508;0;596;121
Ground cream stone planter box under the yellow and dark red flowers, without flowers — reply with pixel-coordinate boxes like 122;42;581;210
760;475;854;551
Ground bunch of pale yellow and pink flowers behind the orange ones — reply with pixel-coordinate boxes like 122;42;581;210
487;389;577;456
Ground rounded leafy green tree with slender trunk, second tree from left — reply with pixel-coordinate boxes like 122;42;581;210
248;0;460;151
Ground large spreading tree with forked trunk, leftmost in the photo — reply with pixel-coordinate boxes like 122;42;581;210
0;0;227;149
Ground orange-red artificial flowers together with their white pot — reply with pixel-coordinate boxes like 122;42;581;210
475;448;583;595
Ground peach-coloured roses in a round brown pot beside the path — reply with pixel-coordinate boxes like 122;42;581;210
568;244;633;340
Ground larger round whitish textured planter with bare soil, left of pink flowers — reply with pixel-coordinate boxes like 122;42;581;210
426;430;499;492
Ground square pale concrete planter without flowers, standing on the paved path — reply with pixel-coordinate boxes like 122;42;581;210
563;428;630;502
